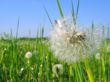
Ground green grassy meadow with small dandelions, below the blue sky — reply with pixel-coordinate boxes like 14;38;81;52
0;0;110;82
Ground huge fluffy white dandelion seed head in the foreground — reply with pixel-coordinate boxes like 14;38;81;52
50;18;103;64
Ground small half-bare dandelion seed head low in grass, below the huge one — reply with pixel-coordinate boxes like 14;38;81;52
52;64;63;77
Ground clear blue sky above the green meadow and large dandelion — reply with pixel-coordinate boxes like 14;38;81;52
0;0;110;37
